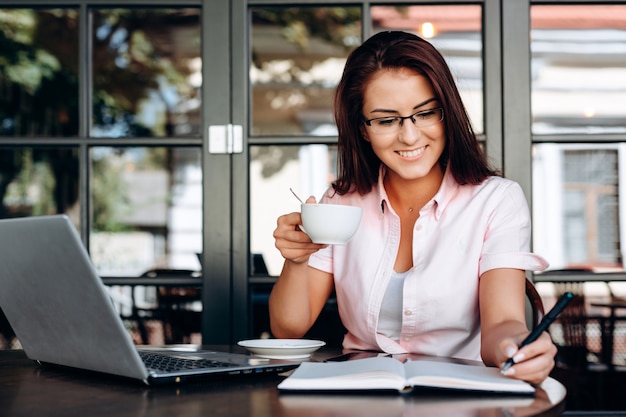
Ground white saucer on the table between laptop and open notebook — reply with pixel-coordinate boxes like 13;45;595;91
237;339;326;359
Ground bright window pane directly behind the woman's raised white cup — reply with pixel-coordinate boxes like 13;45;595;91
250;145;337;275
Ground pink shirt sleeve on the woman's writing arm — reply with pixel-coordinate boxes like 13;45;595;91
479;182;549;275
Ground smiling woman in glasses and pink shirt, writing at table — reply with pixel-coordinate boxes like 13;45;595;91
270;32;556;383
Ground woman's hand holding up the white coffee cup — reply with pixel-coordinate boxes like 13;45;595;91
274;197;328;264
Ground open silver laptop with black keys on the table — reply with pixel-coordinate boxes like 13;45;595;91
0;215;298;385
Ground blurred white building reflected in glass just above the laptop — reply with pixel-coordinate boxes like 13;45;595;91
90;148;202;276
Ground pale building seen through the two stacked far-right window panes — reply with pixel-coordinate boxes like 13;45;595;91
531;5;626;271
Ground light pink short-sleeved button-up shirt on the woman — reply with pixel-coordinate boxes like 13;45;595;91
309;171;548;360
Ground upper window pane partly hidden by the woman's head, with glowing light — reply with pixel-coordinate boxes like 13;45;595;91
371;5;484;133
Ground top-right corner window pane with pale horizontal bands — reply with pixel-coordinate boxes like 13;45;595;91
531;4;626;135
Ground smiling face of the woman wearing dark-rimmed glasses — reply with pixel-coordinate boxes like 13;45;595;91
363;68;446;181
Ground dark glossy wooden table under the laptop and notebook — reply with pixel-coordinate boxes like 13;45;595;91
0;350;566;417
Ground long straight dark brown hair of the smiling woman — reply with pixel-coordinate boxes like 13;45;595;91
332;31;497;194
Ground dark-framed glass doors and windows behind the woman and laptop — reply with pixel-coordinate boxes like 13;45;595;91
0;0;626;406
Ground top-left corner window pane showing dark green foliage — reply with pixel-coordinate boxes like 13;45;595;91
0;9;79;137
